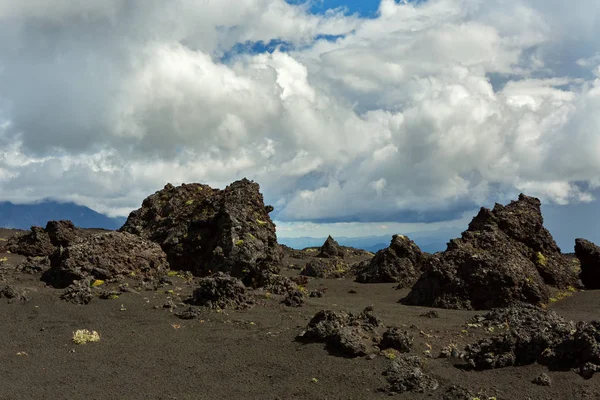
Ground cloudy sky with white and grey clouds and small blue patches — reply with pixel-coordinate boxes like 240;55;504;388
0;0;600;247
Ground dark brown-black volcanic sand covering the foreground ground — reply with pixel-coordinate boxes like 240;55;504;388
0;234;600;400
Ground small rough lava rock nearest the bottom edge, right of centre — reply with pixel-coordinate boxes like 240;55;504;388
383;356;439;393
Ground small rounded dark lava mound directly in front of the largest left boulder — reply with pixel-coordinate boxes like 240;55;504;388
189;272;250;310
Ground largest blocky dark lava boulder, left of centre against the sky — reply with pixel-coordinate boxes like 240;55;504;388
120;179;281;285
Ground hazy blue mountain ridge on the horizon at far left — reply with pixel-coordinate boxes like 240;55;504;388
0;200;127;229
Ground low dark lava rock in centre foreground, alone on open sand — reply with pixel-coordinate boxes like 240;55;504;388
296;308;381;357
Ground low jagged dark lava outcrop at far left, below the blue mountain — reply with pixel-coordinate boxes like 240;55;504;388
7;220;91;257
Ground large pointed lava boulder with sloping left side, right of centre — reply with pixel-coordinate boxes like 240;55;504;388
402;194;581;310
